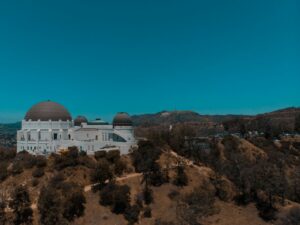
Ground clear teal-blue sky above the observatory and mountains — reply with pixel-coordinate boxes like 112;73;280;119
0;0;300;122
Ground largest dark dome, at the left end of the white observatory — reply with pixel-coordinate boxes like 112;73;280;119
25;101;72;121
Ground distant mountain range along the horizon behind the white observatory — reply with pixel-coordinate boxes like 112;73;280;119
0;107;300;135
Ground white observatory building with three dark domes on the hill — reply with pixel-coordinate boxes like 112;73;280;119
17;101;136;155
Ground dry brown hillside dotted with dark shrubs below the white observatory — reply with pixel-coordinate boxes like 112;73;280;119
0;136;300;225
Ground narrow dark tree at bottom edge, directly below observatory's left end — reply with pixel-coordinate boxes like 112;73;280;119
9;186;33;225
